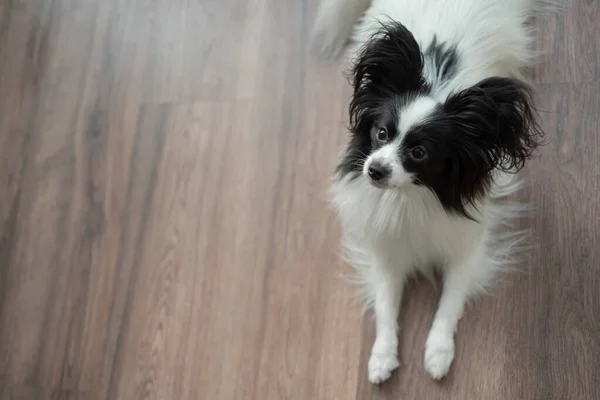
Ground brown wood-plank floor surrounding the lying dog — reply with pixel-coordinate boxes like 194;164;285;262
0;0;600;400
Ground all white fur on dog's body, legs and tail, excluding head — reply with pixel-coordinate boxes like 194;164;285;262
314;0;556;383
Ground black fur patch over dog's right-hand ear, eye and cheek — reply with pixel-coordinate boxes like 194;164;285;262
400;77;543;217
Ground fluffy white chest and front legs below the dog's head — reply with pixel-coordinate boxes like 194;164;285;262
331;170;525;383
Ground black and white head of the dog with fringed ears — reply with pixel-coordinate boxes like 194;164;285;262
338;23;542;216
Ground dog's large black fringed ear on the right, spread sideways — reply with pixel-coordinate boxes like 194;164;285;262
443;77;543;211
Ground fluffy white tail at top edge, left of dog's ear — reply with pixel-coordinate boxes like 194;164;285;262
311;0;371;58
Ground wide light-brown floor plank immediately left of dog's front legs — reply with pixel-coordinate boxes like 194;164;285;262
103;91;360;399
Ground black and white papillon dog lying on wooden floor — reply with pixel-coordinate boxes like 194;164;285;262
312;0;544;383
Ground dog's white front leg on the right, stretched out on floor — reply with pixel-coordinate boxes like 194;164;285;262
424;241;486;379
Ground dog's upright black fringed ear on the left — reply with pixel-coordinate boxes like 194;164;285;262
349;21;425;134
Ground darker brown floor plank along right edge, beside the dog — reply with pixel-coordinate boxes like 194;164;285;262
511;82;600;399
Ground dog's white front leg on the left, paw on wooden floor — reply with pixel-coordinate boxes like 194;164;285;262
368;265;405;383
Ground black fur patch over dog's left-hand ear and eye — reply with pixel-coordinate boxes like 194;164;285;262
337;22;429;176
